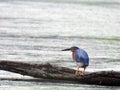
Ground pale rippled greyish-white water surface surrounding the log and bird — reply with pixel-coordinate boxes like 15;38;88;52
0;0;120;90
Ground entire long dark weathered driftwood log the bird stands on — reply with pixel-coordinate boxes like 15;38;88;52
0;61;120;86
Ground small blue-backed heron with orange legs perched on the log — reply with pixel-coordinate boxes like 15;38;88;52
62;46;89;76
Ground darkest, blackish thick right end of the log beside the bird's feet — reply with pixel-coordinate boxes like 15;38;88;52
78;70;120;86
